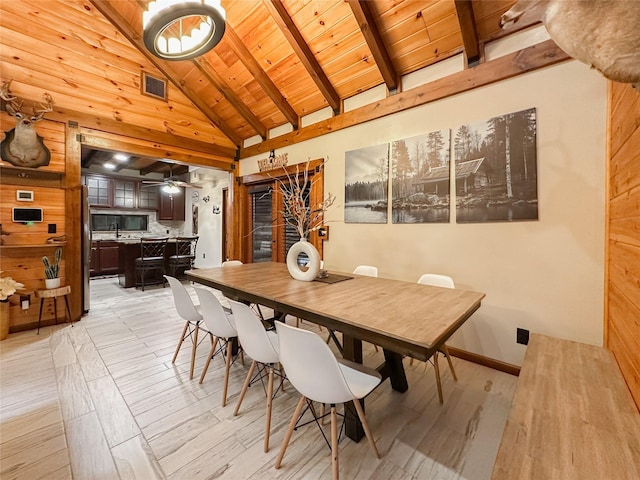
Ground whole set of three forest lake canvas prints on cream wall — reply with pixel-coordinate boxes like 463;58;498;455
344;108;538;223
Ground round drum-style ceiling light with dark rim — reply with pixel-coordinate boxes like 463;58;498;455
142;0;226;60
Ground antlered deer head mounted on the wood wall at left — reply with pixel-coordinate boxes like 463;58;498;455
0;80;53;168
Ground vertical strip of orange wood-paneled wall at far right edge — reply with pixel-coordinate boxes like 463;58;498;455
605;83;640;408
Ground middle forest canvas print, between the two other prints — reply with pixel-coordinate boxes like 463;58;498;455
391;129;451;223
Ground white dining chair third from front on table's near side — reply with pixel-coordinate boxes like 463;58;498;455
194;287;242;407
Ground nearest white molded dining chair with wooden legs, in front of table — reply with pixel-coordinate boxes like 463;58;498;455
275;322;381;480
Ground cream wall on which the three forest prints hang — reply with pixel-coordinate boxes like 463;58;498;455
240;62;607;365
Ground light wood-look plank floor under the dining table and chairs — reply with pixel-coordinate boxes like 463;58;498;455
0;278;517;480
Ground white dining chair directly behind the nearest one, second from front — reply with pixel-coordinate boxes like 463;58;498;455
229;300;284;453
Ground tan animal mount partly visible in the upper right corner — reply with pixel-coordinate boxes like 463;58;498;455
500;0;640;90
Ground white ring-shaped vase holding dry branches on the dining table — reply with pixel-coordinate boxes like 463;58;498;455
279;160;336;282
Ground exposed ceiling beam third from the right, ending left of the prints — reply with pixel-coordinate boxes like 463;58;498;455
263;0;340;115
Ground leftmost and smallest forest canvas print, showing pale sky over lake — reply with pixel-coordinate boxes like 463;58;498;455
344;143;389;223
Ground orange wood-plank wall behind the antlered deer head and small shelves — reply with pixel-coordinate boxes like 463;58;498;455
0;112;68;331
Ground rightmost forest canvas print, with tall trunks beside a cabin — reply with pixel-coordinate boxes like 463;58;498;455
454;108;538;223
